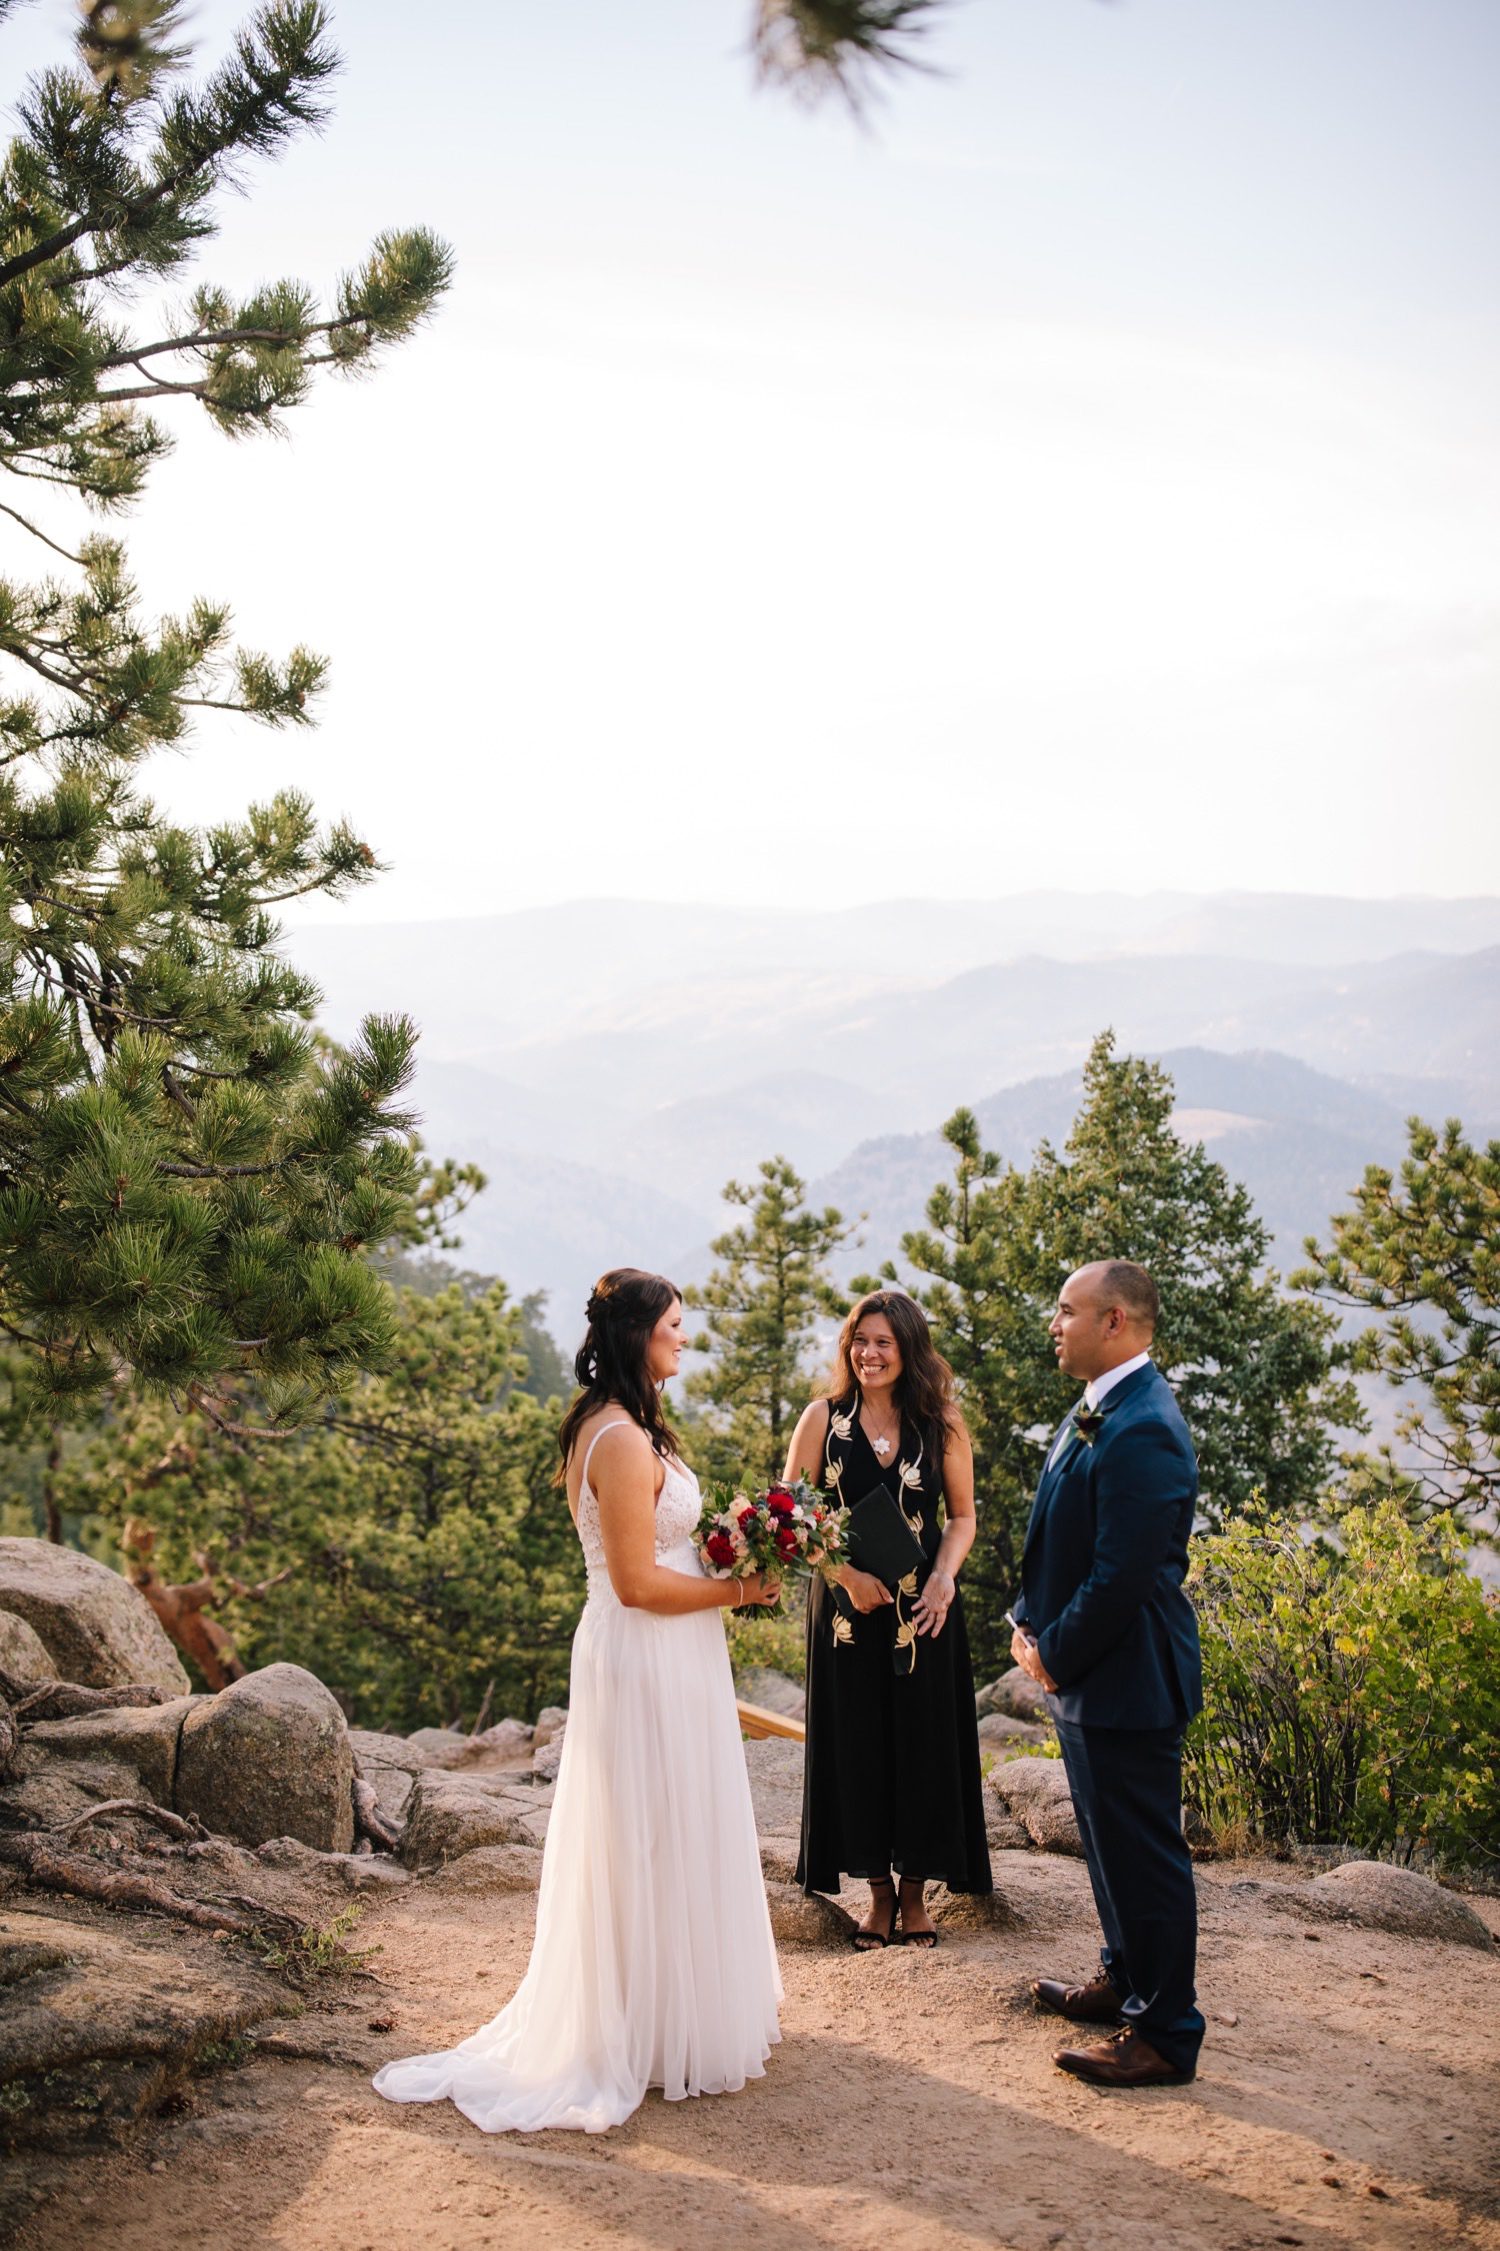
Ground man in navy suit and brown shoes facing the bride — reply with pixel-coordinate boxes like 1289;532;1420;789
1011;1258;1203;2087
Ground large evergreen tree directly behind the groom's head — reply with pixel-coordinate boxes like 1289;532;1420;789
890;1033;1358;1661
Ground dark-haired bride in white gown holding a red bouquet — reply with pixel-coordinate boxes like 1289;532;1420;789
374;1267;782;2134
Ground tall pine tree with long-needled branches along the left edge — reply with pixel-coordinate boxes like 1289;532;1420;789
0;0;448;1420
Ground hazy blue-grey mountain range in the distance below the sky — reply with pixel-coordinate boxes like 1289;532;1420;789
288;894;1500;1342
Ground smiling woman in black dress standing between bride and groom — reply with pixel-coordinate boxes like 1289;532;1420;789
786;1290;991;1952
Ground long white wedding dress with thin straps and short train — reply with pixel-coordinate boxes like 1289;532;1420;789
374;1423;782;2134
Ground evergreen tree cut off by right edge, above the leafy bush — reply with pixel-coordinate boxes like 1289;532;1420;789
1293;1119;1500;1540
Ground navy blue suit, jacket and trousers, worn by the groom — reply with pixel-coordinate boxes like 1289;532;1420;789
1016;1366;1203;2071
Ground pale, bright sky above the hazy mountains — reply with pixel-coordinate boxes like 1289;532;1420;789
0;0;1500;913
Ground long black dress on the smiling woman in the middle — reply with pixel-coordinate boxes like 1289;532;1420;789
797;1400;991;1891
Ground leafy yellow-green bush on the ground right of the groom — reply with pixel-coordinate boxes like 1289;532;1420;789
1185;1501;1500;1868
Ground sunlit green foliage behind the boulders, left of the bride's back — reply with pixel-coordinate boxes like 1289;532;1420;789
59;1283;583;1731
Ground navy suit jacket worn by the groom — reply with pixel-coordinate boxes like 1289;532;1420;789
1016;1366;1203;1729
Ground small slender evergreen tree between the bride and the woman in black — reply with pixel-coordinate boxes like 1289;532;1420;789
687;1157;851;1486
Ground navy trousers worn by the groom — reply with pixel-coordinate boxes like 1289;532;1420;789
1056;1720;1203;2071
